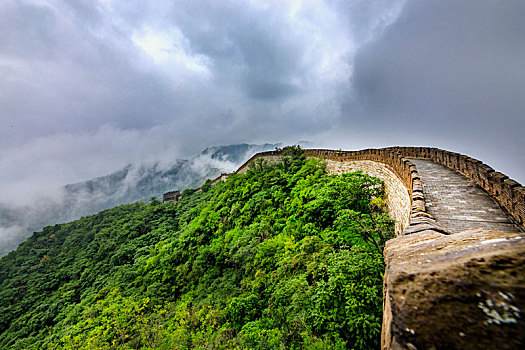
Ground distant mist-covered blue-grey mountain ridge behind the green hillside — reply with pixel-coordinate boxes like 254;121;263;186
0;144;280;256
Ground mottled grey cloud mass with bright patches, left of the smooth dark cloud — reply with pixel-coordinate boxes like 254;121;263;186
0;0;370;202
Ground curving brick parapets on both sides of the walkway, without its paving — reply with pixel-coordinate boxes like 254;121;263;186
236;146;525;235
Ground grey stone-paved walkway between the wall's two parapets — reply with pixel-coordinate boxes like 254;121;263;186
410;159;520;233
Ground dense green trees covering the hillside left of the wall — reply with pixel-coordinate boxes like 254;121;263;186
0;148;392;349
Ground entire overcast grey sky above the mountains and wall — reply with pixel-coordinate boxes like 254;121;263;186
0;0;525;206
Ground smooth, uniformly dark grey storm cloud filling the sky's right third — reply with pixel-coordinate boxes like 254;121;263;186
345;0;525;182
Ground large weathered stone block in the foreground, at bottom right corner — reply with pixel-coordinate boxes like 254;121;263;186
382;229;525;349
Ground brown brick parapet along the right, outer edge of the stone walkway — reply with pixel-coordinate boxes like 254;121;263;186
387;146;525;230
